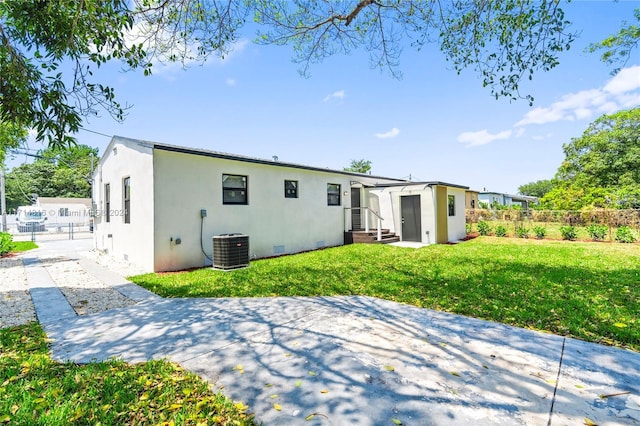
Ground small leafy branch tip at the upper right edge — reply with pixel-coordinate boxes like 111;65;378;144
588;9;640;74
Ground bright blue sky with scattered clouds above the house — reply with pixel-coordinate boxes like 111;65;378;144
8;1;640;194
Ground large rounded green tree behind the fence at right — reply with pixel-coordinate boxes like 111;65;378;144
542;107;640;209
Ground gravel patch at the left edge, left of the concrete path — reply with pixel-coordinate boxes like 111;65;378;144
0;257;36;328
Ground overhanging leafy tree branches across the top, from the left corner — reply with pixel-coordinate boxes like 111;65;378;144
0;0;574;146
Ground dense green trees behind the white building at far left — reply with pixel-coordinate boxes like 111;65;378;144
6;145;98;210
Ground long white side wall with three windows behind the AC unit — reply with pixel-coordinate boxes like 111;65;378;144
153;149;351;271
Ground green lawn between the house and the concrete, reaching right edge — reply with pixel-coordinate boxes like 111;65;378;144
130;237;640;351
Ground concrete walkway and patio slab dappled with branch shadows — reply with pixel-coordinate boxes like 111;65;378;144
13;242;640;426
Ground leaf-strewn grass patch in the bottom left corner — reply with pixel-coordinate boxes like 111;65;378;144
0;323;255;426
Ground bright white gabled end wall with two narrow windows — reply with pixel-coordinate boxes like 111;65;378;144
93;137;154;271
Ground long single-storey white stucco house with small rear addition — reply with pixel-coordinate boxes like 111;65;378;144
93;136;468;272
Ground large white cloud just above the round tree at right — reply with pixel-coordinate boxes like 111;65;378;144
515;65;640;127
